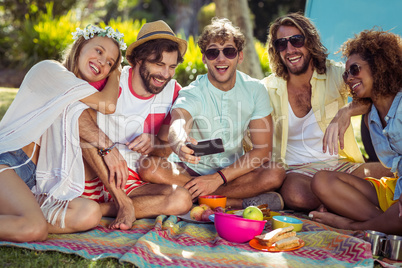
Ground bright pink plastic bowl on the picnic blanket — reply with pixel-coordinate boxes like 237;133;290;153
214;213;267;243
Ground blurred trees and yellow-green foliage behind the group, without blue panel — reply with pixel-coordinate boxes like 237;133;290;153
0;0;305;87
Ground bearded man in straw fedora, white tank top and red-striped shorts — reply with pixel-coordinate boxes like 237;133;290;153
80;20;192;229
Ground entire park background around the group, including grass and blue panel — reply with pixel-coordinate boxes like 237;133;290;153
0;0;402;267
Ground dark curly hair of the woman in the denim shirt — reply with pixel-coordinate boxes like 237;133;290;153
341;29;402;98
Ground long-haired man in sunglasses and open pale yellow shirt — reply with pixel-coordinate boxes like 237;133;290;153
263;13;388;214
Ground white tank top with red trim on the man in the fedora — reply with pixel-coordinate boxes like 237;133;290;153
98;66;181;170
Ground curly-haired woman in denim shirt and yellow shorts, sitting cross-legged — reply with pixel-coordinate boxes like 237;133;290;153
310;30;402;235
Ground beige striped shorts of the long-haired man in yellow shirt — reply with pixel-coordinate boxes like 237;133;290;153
286;159;363;178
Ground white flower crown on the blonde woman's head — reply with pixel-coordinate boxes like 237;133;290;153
71;24;127;50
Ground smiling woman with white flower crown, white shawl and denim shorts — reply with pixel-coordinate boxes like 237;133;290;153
0;25;126;242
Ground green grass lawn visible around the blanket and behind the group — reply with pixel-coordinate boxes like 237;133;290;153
0;87;365;267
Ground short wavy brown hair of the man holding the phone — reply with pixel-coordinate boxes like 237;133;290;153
198;17;246;54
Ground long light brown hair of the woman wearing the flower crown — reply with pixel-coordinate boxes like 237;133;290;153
63;36;122;77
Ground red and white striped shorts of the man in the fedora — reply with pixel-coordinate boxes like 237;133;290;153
81;169;149;203
